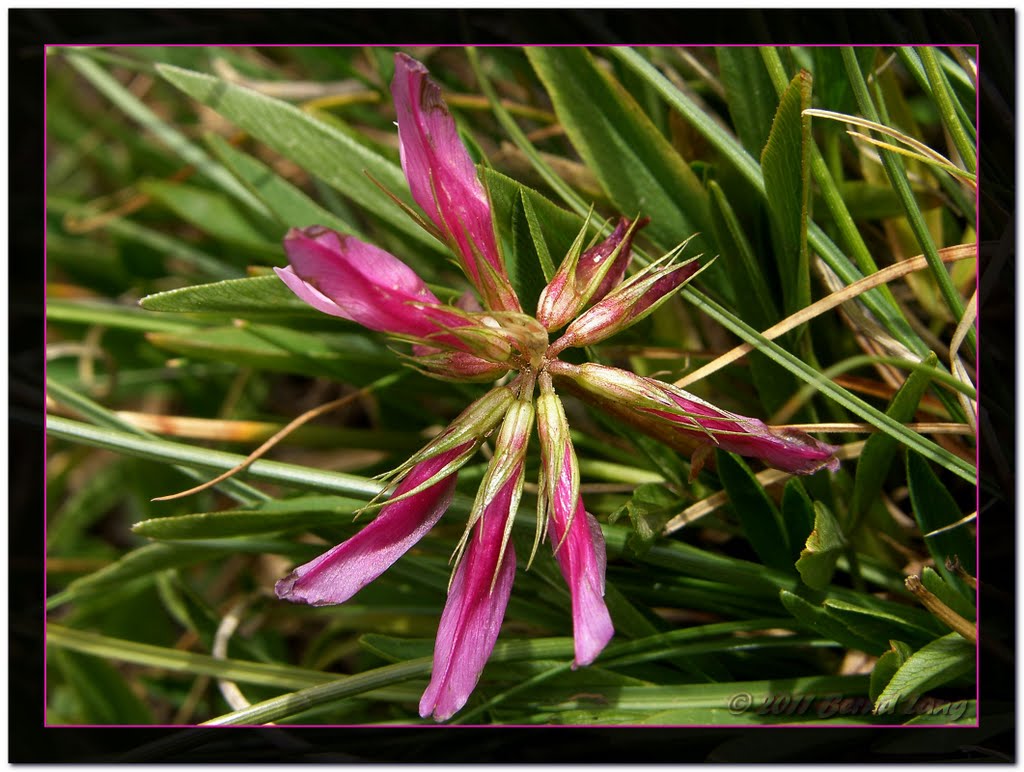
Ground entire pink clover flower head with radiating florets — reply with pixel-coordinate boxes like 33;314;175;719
276;53;838;721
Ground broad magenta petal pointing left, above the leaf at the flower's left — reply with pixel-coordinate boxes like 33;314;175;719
278;227;438;336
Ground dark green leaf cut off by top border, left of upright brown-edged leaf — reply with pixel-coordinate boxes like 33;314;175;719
715;46;778;158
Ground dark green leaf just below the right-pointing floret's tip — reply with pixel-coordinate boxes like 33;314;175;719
716;451;793;572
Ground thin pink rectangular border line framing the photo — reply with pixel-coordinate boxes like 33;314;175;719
43;43;981;729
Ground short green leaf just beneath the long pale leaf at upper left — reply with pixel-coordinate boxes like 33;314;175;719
207;134;359;235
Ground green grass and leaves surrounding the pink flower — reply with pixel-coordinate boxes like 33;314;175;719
45;46;974;724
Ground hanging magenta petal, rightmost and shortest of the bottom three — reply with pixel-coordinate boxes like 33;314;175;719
551;447;615;667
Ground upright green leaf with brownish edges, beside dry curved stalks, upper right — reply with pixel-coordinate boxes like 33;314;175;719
761;71;811;314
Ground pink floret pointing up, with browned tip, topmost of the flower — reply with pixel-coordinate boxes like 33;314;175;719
391;53;520;311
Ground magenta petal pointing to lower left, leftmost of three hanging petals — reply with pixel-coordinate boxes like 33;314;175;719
274;443;468;606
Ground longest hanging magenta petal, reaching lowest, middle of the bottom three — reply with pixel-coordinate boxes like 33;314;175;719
420;468;518;721
